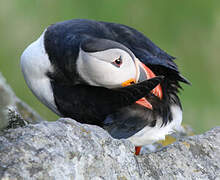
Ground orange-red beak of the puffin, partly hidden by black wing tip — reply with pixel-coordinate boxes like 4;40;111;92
122;60;163;110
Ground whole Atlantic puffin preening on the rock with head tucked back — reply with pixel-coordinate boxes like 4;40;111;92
21;19;190;154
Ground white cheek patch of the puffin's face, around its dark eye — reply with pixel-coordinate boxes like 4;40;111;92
76;49;137;88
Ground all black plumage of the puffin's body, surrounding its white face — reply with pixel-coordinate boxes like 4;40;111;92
44;19;189;138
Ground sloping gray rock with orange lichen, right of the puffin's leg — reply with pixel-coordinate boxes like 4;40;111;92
137;127;220;180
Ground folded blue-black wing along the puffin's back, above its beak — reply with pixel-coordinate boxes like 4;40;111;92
104;23;190;84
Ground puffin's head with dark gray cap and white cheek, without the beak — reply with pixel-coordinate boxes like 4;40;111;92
76;38;139;88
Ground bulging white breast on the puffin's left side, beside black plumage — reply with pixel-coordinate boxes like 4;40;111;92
21;33;59;115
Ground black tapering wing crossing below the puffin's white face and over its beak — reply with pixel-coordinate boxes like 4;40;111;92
51;76;163;125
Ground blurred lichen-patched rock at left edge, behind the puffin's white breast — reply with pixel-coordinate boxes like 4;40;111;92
0;73;42;130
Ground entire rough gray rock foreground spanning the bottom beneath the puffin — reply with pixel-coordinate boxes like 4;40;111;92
0;118;220;180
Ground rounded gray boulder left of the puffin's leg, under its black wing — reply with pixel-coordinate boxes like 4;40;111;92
0;119;139;180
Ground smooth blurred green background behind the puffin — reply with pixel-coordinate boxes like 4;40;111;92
0;0;220;133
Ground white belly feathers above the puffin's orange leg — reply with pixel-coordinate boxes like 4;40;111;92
128;105;182;146
